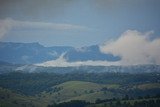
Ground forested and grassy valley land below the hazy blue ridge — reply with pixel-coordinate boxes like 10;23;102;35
0;72;160;107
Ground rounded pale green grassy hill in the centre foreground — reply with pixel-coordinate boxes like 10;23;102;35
37;81;121;103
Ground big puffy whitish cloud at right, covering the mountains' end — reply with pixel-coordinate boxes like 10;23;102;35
100;30;160;65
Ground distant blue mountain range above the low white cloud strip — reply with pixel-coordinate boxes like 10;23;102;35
0;42;121;64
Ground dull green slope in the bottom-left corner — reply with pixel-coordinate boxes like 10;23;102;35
0;88;42;107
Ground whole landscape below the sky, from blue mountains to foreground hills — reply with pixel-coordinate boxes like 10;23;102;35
0;42;160;107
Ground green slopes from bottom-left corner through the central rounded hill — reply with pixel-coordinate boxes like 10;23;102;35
0;81;121;107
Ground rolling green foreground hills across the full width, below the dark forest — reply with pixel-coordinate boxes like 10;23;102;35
0;78;160;107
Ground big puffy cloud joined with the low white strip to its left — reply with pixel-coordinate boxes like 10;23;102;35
36;30;160;67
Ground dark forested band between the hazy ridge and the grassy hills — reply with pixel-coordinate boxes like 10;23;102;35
0;72;160;95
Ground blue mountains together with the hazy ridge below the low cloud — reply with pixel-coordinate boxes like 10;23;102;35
0;42;160;74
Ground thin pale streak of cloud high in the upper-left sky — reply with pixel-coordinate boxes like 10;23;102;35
0;18;90;38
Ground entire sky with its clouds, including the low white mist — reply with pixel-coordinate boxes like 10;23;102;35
0;0;160;66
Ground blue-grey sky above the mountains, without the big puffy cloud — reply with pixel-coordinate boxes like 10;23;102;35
0;0;160;47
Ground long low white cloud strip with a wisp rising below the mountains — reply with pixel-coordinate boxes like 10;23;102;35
35;53;119;67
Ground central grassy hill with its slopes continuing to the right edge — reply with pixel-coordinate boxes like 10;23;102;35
38;81;160;103
